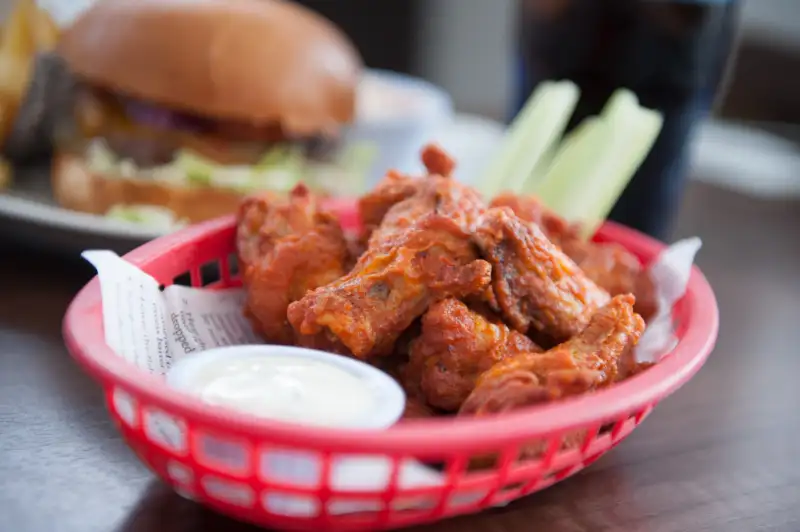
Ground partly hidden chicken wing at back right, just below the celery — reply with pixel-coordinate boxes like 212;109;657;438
491;194;656;318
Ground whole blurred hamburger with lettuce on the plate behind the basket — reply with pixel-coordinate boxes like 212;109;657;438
52;0;371;227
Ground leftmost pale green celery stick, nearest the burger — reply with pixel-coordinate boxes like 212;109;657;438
478;81;580;197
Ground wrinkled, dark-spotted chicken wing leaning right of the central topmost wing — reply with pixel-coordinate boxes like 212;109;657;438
474;208;609;344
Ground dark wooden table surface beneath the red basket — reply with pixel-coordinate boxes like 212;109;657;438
0;181;800;532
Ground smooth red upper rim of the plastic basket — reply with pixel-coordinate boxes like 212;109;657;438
63;210;719;455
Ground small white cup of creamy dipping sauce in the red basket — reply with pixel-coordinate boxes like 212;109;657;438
167;346;405;428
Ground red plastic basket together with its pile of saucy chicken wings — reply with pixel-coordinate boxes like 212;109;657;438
65;146;717;530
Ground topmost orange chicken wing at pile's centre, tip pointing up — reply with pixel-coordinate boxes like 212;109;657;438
289;146;491;359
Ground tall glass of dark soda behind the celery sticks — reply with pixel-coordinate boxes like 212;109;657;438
514;0;740;240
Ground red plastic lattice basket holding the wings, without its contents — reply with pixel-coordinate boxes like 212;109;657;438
64;202;718;530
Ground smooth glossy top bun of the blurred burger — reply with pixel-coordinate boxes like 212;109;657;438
58;0;362;135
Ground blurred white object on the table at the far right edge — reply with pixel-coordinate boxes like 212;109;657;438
692;120;800;198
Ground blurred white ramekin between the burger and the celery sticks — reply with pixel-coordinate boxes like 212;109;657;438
345;70;454;186
